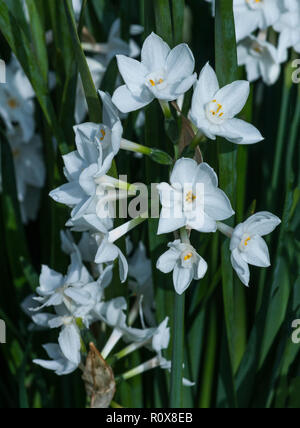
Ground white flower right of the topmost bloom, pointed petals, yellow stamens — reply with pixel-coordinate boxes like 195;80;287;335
190;64;263;144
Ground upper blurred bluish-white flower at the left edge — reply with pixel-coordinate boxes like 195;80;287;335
0;59;35;142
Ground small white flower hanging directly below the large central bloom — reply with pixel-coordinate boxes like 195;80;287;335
156;240;207;294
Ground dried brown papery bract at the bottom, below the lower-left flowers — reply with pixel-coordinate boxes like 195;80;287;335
82;343;116;409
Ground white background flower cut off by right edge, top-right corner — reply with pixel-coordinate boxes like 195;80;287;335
273;0;300;62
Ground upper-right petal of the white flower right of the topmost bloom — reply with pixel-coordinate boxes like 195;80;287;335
216;80;250;118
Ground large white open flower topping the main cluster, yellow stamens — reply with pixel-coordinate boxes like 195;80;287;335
113;33;197;113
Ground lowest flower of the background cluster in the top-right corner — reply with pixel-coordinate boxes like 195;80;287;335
237;36;281;85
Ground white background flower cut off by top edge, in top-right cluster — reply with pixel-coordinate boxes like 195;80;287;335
233;0;285;41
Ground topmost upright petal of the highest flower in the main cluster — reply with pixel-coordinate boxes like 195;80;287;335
141;33;171;72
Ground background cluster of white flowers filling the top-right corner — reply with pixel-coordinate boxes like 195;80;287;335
207;0;300;85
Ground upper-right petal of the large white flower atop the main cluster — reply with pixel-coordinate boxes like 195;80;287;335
166;44;195;83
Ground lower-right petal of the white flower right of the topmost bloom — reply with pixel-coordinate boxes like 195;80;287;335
223;119;264;144
